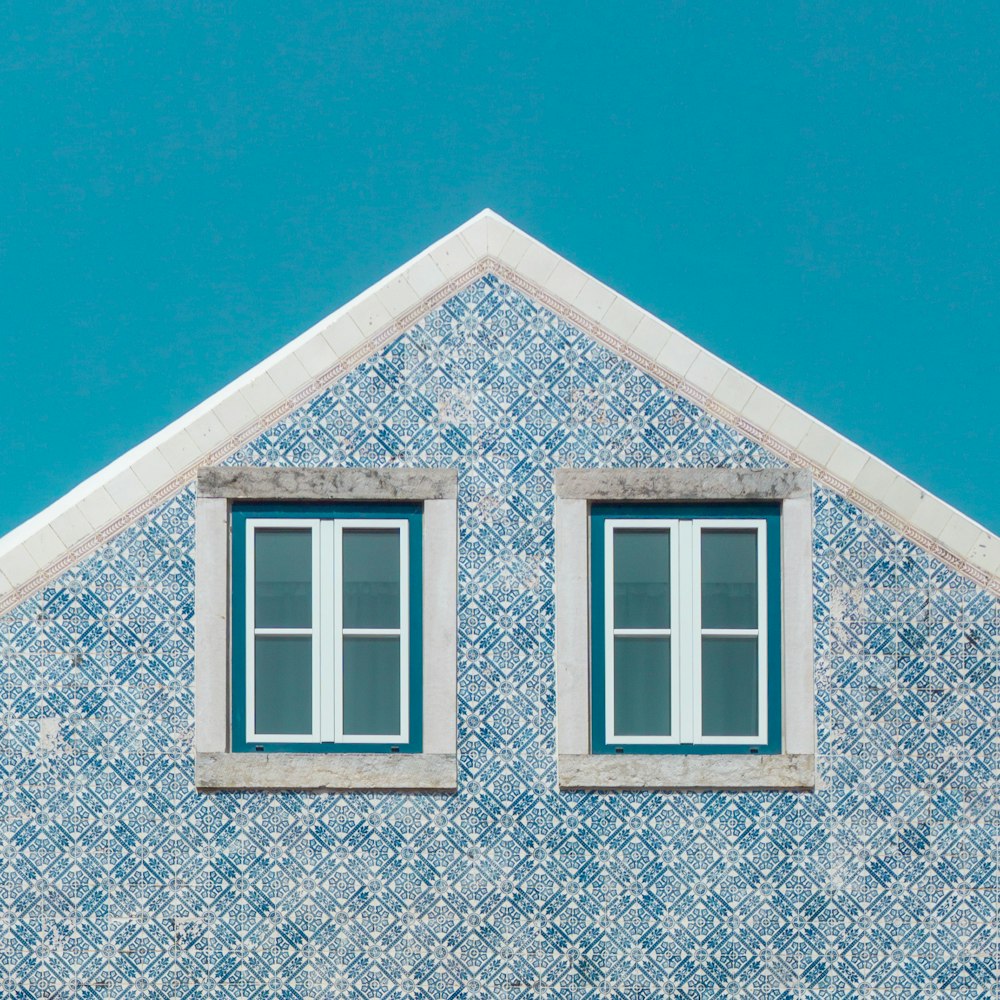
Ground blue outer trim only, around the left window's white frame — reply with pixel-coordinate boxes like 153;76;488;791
230;502;423;753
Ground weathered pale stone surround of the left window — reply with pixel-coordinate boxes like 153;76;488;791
195;466;458;792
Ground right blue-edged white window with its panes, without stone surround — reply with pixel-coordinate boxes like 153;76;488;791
591;504;781;753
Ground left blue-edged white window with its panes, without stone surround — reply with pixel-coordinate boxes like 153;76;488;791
232;503;422;753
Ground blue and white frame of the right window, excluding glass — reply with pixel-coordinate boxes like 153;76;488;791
589;502;781;754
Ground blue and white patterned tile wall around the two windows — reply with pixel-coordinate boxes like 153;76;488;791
0;277;1000;1000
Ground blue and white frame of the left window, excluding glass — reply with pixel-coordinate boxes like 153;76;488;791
231;502;423;753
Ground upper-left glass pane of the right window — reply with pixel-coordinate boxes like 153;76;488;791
614;528;670;628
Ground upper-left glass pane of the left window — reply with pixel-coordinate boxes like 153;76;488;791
253;528;312;628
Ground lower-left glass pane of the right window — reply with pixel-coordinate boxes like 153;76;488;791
615;636;670;736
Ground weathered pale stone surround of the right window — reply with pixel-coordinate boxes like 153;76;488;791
553;469;816;791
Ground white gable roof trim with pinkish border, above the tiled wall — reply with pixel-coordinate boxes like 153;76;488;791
0;209;1000;611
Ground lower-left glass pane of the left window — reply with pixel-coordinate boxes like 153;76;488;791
253;635;312;735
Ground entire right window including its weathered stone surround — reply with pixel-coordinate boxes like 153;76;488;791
555;469;815;790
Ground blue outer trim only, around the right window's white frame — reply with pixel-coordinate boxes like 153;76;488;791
590;503;781;754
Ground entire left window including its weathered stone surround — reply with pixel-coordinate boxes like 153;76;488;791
195;467;457;791
